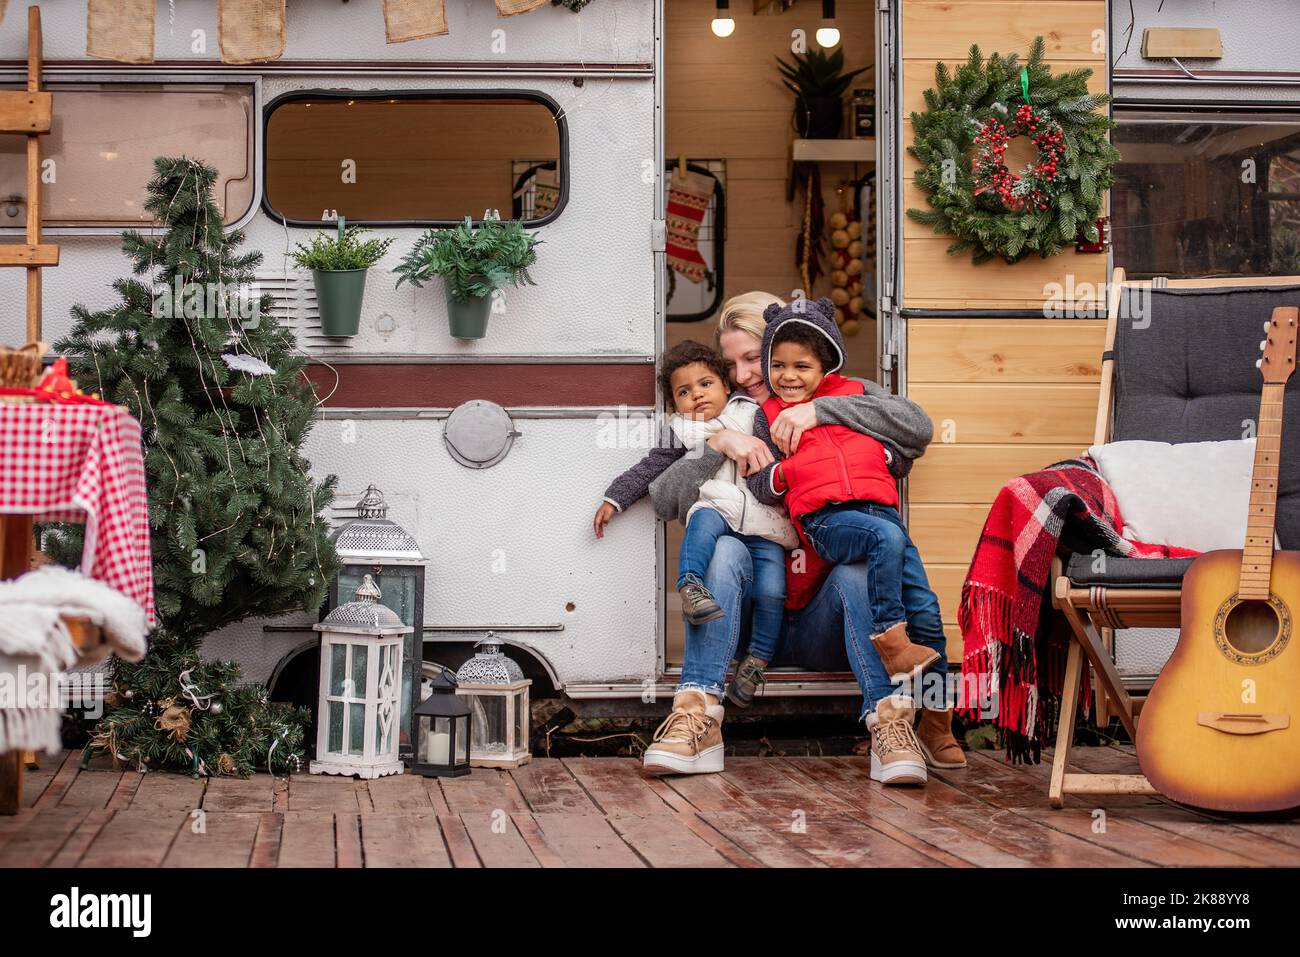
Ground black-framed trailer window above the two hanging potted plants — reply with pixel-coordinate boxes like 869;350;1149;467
265;92;566;226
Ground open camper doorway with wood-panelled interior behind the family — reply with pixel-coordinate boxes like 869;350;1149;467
660;0;880;706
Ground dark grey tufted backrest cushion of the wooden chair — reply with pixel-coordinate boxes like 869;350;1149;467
1112;286;1300;547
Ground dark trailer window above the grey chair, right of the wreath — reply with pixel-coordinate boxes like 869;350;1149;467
1110;108;1300;278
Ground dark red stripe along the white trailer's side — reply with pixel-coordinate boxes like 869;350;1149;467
299;363;654;408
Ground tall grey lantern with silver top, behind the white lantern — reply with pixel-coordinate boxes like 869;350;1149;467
330;485;429;755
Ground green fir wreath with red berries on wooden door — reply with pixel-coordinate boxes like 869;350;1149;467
907;36;1119;263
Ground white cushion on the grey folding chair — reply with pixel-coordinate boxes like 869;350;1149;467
1088;438;1255;551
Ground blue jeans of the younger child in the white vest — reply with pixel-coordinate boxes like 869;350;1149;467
677;508;785;662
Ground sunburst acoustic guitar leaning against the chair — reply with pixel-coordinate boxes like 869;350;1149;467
1138;307;1300;811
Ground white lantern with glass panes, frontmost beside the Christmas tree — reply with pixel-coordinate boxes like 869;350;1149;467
311;575;411;778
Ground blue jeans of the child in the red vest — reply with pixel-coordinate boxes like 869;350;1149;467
801;502;924;635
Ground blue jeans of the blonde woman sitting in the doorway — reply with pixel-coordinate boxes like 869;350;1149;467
677;538;948;716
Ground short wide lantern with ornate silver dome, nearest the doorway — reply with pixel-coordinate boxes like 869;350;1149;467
456;632;533;767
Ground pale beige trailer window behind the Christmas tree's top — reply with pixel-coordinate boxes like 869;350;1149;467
0;83;255;226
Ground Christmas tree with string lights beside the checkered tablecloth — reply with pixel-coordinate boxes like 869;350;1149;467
46;157;338;775
